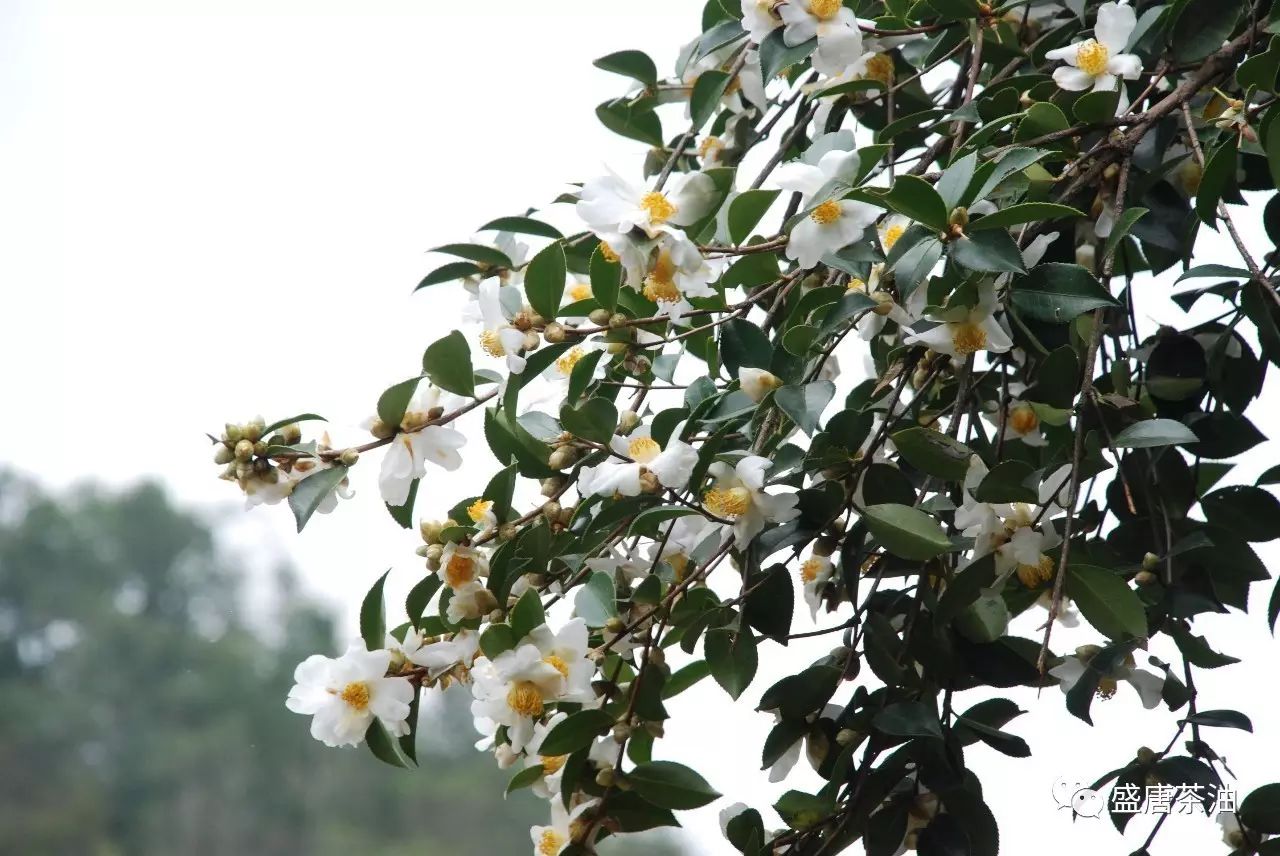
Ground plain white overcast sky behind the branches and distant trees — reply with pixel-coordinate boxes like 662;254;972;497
0;0;1280;853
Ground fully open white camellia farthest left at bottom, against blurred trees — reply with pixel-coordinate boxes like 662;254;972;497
284;645;413;746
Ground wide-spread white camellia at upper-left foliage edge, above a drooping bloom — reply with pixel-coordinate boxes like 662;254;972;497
576;171;716;239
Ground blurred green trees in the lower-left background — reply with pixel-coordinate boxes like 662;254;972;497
0;473;677;856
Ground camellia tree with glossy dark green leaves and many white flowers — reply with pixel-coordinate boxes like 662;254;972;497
207;0;1280;856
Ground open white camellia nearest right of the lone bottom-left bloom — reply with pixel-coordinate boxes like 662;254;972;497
471;642;564;752
